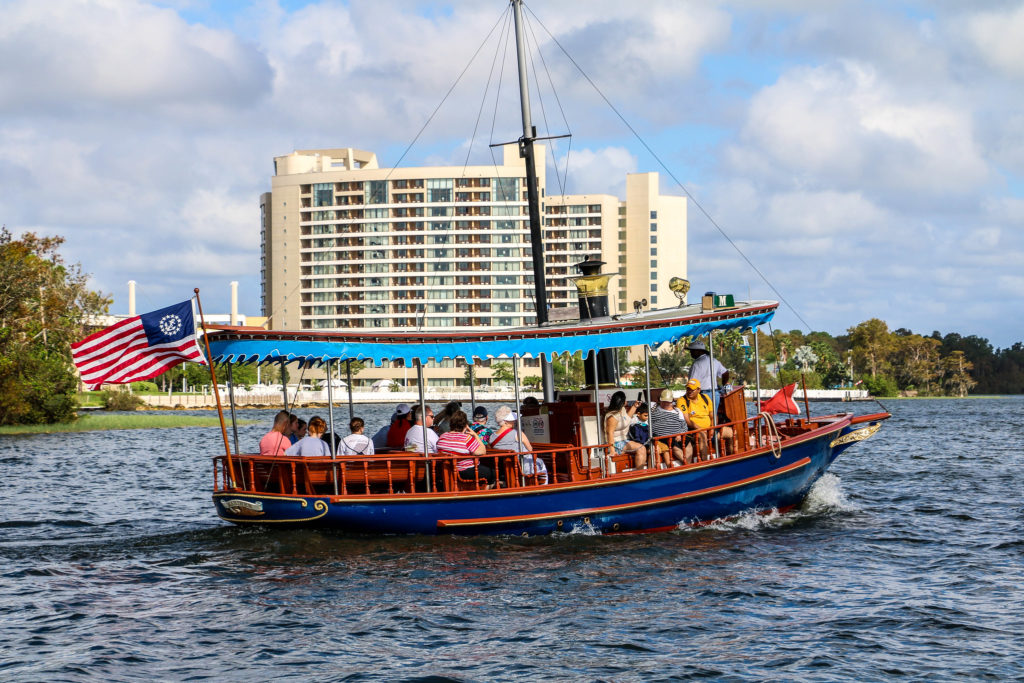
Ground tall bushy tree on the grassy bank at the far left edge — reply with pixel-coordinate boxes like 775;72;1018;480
0;227;111;424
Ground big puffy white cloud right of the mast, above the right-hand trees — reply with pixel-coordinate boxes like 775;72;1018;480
732;61;988;195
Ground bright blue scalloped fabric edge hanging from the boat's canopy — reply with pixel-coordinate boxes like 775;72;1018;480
210;310;775;365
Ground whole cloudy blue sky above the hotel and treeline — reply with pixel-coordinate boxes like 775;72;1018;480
0;0;1024;346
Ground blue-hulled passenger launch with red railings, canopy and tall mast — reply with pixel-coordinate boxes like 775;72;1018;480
204;0;890;536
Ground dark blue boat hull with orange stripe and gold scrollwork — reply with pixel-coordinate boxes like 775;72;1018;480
214;415;870;536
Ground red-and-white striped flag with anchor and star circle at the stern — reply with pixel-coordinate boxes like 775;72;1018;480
71;299;207;387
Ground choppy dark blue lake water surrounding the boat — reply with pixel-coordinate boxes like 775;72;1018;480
0;397;1024;681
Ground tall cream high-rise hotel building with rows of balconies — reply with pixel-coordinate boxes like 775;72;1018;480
260;144;686;348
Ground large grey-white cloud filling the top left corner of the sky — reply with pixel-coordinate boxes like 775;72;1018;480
0;0;270;113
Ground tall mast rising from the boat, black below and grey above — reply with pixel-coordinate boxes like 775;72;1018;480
510;0;555;402
